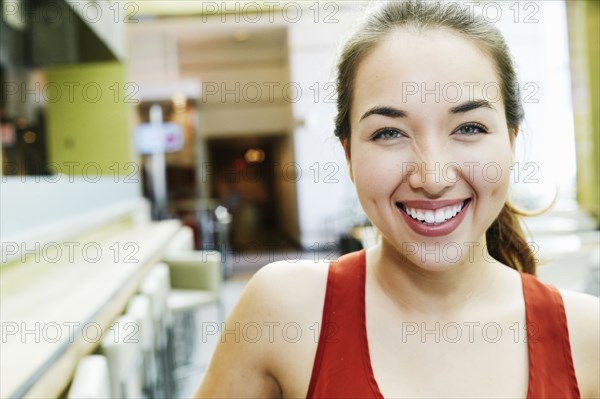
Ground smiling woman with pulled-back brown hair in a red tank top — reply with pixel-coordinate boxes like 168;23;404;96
197;2;600;398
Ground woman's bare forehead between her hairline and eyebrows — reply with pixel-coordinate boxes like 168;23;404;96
352;29;501;116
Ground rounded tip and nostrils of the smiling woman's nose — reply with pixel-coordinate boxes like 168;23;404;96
408;154;459;197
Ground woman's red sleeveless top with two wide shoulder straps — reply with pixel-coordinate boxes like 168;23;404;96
307;250;580;399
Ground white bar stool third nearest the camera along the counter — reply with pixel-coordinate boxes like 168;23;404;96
125;295;157;398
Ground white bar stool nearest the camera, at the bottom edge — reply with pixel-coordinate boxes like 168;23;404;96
67;355;111;399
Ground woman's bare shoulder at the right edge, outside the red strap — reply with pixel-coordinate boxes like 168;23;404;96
560;289;600;398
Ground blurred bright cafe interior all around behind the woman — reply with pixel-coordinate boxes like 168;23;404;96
0;0;600;397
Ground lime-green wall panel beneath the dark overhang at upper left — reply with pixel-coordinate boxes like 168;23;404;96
45;62;139;176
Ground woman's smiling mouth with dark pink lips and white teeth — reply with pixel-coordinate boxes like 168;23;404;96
396;198;471;237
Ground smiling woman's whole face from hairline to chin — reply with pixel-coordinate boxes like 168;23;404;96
346;30;513;270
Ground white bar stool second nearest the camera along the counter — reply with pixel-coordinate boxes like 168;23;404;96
102;315;143;398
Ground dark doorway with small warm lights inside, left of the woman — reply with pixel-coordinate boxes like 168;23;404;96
206;134;299;252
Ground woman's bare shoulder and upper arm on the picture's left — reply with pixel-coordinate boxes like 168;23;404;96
196;261;328;397
